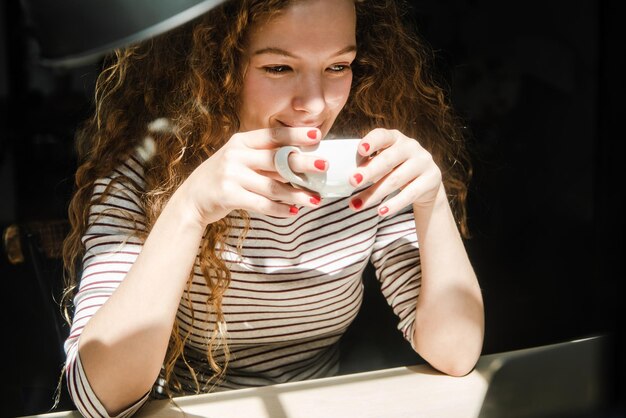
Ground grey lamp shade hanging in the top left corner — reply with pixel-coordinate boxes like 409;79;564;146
21;0;224;67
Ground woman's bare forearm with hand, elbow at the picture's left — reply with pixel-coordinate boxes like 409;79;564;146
73;128;321;415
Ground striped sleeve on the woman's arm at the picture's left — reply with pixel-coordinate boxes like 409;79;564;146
64;154;148;417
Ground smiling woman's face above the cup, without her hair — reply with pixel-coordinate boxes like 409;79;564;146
239;0;356;136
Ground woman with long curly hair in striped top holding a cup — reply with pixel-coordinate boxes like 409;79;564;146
65;0;483;416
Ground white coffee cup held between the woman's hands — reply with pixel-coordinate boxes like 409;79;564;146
274;138;365;197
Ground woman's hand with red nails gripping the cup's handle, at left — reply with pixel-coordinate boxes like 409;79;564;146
176;127;321;226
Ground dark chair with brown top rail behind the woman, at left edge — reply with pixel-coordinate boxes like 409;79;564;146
0;220;73;416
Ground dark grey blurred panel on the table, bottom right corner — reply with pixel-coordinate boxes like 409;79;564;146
479;336;615;418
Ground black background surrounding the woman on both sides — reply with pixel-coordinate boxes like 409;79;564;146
0;0;626;416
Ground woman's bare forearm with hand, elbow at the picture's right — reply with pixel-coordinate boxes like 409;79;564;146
351;129;484;375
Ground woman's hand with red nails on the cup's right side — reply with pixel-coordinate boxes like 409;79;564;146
350;128;443;216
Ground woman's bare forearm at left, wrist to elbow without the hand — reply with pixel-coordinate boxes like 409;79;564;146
79;192;204;415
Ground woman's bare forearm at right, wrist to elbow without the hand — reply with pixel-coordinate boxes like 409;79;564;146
413;185;484;376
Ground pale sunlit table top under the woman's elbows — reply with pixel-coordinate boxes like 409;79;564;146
18;336;604;418
